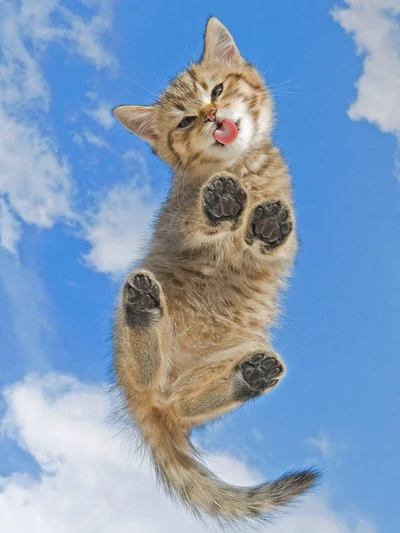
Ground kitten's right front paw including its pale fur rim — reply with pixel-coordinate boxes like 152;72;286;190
245;200;294;254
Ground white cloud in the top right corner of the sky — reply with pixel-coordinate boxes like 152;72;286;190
332;0;400;139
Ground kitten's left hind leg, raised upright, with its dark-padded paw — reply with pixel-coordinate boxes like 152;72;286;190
115;270;168;392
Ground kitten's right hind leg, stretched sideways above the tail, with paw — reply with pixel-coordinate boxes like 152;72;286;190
169;349;285;425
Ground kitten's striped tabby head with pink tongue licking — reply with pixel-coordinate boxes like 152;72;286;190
114;18;273;171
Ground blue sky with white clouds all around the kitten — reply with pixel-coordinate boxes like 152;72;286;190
0;0;400;533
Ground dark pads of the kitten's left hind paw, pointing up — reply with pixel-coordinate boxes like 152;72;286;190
124;274;161;326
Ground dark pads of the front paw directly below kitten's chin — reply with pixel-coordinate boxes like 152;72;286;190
203;175;246;226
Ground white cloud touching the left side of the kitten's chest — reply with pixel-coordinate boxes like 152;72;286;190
83;151;158;275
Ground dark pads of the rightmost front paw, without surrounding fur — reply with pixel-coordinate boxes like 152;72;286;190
248;200;293;250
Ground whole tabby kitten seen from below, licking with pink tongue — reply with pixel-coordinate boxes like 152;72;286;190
114;18;318;519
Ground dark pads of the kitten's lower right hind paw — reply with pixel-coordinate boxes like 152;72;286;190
237;353;283;399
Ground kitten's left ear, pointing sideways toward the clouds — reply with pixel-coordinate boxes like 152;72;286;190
113;105;159;144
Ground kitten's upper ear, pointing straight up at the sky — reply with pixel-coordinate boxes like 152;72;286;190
201;17;243;66
